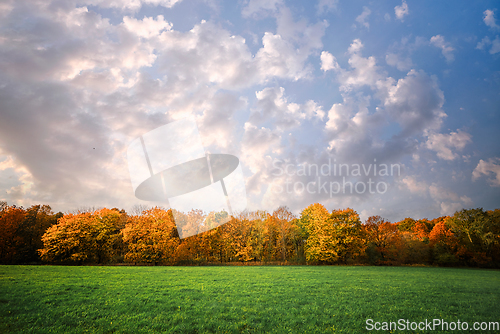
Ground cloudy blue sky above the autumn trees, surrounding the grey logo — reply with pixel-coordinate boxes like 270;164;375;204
0;0;500;222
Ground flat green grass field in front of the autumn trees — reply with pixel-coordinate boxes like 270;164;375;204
0;266;500;333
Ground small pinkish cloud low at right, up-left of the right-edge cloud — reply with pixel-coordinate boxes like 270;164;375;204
425;130;471;160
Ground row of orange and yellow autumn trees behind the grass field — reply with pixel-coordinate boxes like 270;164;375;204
0;202;500;268
